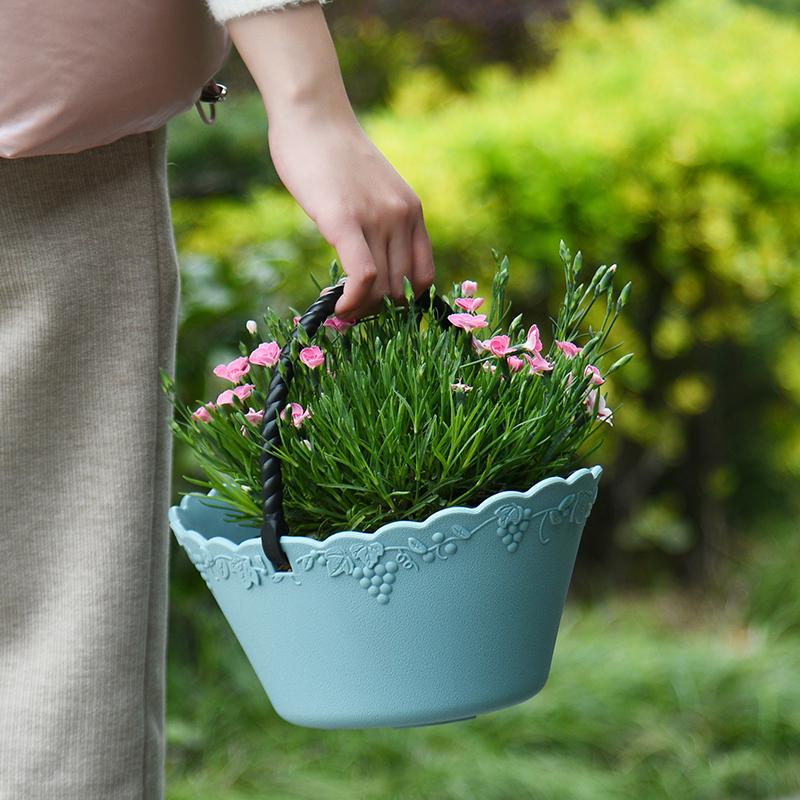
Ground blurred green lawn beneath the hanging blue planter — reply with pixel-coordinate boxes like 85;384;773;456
162;576;800;800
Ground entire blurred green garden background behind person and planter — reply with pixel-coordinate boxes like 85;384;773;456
168;0;800;800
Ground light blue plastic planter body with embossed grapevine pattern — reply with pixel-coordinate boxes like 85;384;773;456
170;467;602;728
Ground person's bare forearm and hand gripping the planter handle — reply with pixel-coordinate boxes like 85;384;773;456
227;3;433;319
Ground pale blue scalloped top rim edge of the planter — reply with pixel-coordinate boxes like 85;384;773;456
169;466;603;553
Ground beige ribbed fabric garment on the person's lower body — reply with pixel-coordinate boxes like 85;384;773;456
0;130;179;800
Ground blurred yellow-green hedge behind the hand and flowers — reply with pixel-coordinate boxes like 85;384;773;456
173;0;800;581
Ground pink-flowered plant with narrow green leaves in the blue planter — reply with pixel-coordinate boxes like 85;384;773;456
165;243;630;539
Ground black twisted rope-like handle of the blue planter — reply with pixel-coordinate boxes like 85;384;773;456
261;278;453;567
